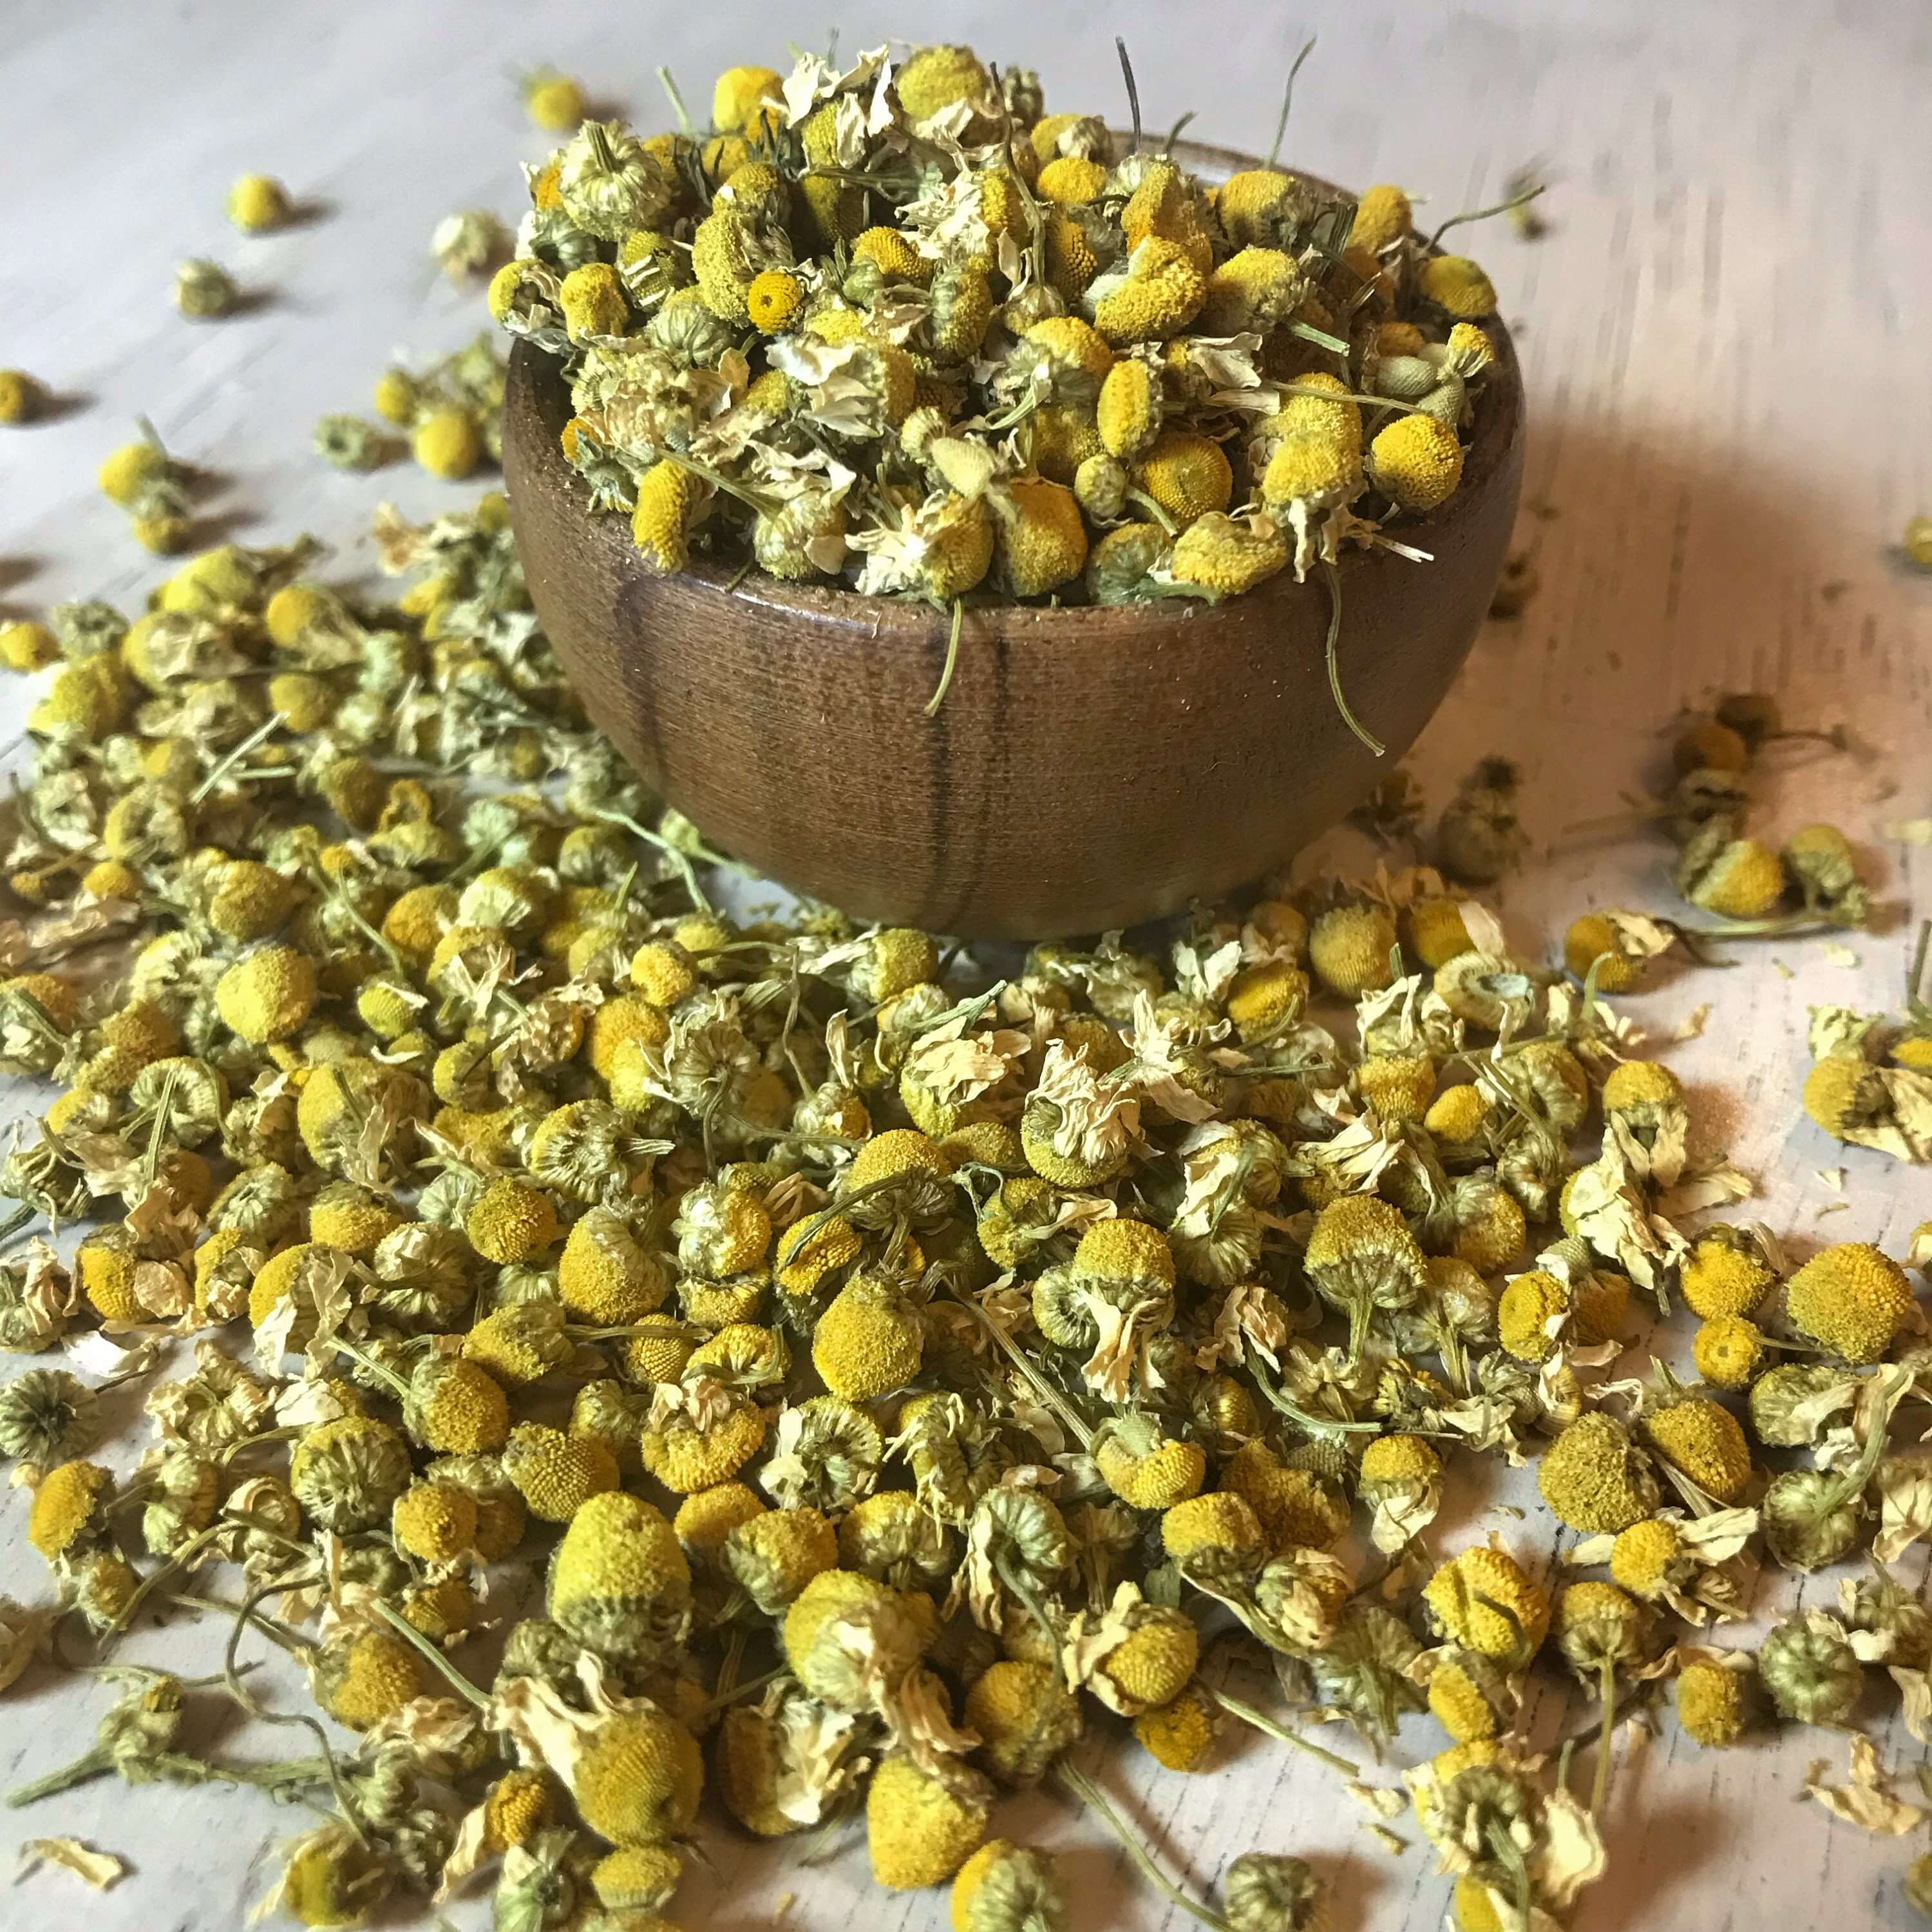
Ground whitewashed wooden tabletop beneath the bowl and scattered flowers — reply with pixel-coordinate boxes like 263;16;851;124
0;0;1932;1932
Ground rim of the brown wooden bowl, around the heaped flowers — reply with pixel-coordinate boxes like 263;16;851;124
510;129;1524;641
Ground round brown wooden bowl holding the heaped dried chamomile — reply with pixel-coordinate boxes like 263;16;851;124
502;143;1522;939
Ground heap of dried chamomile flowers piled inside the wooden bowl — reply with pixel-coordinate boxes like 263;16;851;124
491;46;1495;605
